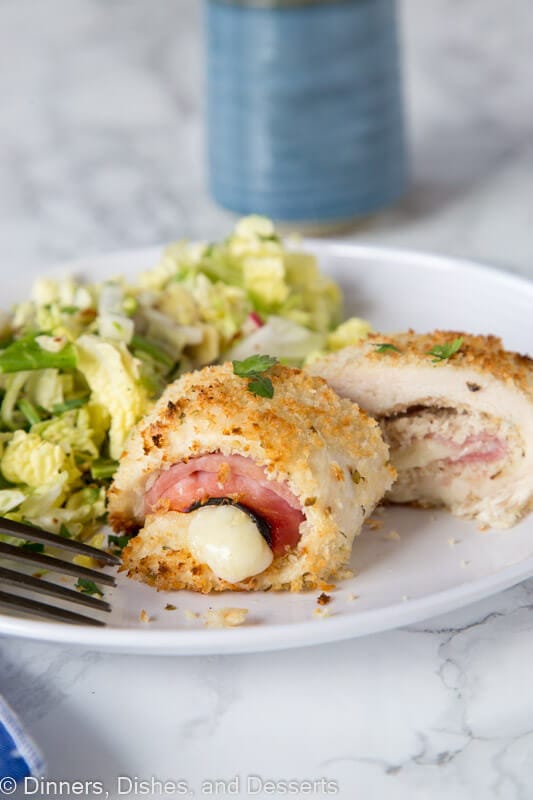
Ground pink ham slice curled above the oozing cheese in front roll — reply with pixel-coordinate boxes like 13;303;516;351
145;453;305;555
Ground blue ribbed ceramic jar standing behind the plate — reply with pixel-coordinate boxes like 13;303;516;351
206;0;407;224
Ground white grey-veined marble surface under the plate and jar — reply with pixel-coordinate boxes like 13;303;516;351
0;0;533;800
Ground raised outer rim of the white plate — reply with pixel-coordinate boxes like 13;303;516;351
0;237;533;656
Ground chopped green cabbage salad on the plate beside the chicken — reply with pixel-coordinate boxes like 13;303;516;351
0;216;370;546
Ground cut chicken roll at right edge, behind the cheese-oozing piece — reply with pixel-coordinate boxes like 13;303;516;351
308;331;533;528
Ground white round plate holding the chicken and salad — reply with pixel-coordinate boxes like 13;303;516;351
0;241;533;654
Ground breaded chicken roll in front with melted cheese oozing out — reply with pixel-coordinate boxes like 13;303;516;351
109;364;394;592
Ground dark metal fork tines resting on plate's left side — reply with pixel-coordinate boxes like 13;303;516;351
0;517;120;625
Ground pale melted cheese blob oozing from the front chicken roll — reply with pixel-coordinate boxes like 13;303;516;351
188;505;274;583
